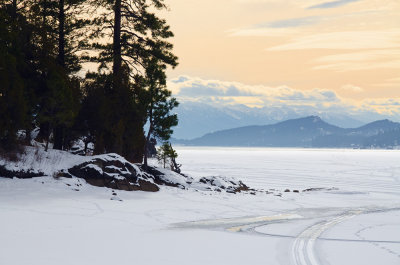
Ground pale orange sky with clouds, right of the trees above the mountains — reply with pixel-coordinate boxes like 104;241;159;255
162;0;400;116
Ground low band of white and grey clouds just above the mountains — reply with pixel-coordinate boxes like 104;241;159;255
168;76;400;121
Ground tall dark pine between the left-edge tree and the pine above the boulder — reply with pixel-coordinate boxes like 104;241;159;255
27;0;88;150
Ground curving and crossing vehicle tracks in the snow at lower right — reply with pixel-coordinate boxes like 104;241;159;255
174;207;400;265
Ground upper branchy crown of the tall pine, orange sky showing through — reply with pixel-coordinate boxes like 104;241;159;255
93;0;177;76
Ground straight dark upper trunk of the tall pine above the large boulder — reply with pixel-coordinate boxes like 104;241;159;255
113;0;122;89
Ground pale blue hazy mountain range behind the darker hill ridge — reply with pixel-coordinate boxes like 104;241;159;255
173;101;394;139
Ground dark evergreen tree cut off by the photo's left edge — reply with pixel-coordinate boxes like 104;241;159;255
0;0;31;150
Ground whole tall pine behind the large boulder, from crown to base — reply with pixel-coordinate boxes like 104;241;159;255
86;0;177;162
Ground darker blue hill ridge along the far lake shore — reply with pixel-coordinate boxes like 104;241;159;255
174;116;400;148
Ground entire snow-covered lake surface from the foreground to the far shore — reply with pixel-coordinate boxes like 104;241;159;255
0;147;400;265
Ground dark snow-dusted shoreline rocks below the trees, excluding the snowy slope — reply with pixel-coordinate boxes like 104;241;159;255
0;148;263;196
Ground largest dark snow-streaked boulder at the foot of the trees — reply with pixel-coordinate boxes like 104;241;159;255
65;154;159;192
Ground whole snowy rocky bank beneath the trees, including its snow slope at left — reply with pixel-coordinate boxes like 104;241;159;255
0;147;256;193
